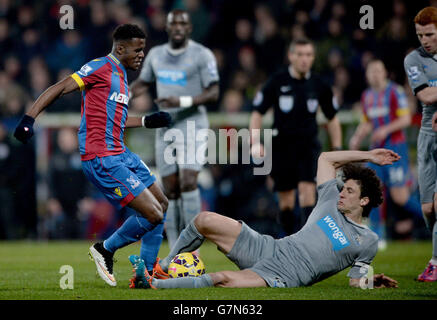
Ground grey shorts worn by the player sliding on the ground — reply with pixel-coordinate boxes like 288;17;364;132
226;221;287;288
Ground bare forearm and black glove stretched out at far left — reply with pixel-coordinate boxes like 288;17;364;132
14;77;79;143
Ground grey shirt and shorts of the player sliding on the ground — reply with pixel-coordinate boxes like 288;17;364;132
237;179;378;287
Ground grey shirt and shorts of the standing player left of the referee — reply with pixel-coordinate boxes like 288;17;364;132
140;40;219;177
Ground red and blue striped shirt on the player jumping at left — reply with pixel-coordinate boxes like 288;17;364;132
71;54;129;160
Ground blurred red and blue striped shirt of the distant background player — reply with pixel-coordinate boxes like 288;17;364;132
361;81;410;147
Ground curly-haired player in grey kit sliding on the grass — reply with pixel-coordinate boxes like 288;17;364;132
130;149;400;288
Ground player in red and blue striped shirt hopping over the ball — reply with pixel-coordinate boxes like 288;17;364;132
14;24;171;286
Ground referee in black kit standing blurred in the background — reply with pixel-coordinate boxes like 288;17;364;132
249;39;342;234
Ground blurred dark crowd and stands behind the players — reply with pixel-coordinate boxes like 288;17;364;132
0;0;430;239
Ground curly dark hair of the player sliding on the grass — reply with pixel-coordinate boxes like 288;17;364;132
342;163;383;217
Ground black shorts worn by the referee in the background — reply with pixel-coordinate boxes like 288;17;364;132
270;135;321;191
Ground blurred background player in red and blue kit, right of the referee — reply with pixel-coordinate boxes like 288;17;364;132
349;59;422;249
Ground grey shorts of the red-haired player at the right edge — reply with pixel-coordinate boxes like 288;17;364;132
417;130;437;203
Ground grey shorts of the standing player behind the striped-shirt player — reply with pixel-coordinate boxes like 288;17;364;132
155;107;209;177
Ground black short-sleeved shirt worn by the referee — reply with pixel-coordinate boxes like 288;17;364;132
253;67;338;137
